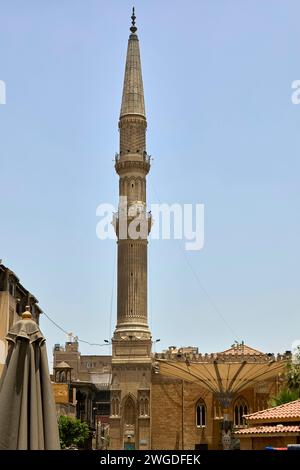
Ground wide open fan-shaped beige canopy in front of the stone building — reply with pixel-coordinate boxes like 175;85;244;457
157;359;287;394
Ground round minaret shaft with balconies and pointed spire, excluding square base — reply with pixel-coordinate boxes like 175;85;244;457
114;14;151;340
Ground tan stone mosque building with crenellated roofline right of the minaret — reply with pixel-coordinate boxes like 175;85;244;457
151;343;285;450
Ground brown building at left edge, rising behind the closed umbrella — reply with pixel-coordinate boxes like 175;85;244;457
0;264;42;376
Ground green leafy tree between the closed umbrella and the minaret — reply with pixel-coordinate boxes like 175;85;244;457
58;416;90;449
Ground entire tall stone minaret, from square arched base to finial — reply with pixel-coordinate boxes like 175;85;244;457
110;8;152;450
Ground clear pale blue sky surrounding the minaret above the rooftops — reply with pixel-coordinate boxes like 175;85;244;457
0;0;300;368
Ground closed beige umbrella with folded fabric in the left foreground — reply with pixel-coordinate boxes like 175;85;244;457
0;311;60;450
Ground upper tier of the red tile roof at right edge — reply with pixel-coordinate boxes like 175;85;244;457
244;399;300;422
